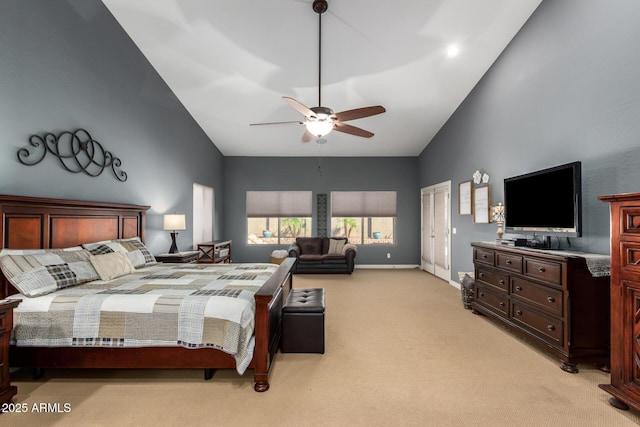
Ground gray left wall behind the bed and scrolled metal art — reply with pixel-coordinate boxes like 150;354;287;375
0;0;223;253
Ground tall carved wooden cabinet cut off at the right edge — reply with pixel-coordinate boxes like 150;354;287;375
599;193;640;410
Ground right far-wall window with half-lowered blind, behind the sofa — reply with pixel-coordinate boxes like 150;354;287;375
331;191;396;245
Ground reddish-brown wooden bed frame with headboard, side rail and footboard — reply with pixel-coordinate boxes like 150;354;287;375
0;195;295;391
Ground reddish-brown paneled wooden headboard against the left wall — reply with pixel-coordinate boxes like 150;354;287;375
0;195;149;296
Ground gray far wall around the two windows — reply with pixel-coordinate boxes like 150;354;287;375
224;157;420;265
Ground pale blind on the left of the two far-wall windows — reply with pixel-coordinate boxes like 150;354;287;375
247;191;313;218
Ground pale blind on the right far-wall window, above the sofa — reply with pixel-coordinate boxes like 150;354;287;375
331;191;396;217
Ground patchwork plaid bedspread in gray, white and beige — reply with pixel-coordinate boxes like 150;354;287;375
6;264;278;375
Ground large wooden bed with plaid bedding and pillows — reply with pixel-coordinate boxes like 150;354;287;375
0;195;294;392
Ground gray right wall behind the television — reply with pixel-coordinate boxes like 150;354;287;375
419;0;640;277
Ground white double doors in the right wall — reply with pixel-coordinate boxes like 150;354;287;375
421;181;451;281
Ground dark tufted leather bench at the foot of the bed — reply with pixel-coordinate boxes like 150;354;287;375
280;288;325;353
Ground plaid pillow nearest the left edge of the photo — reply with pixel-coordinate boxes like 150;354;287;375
0;247;99;297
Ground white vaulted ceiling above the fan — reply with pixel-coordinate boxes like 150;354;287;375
103;0;541;157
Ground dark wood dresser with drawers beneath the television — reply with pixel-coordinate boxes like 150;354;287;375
471;242;610;373
